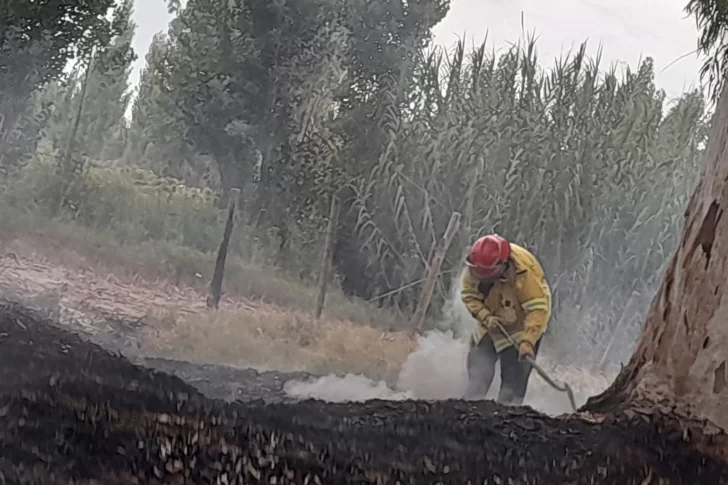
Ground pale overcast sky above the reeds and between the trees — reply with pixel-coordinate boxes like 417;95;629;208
132;0;700;97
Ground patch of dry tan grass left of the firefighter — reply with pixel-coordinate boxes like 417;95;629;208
143;305;416;381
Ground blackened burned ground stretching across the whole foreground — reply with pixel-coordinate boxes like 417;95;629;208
0;304;728;485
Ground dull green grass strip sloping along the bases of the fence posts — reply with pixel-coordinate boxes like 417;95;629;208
0;205;407;322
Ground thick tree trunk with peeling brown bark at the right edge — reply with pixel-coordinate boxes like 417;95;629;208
585;81;728;458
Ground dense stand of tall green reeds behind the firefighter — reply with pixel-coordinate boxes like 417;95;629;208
356;40;707;364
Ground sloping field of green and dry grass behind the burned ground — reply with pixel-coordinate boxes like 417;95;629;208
0;210;416;379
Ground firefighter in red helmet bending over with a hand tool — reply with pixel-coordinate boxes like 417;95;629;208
460;234;551;405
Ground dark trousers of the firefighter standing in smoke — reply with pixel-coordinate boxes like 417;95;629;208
464;335;541;405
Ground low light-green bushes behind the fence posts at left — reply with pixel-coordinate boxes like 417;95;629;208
9;153;319;281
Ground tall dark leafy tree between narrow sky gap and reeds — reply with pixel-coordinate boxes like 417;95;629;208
150;0;448;268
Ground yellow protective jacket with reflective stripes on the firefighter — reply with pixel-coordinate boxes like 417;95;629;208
460;243;551;352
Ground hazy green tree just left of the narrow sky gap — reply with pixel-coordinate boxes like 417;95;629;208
8;0;136;217
